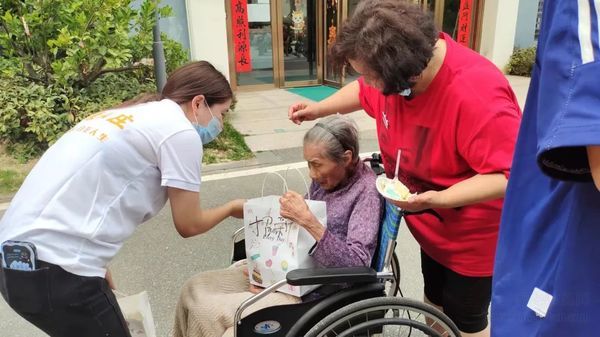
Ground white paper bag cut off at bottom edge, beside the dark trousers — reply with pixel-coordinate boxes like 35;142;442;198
117;291;156;337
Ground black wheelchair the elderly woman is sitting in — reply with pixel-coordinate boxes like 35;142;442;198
231;154;460;337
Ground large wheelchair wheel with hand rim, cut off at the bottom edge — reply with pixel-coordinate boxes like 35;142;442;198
305;297;460;337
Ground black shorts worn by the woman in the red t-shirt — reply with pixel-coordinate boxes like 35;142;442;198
421;250;492;333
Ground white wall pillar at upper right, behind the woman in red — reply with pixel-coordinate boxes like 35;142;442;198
479;0;520;70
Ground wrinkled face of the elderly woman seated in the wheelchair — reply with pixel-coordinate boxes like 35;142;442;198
304;143;352;191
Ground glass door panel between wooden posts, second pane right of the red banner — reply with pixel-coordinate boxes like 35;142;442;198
278;0;322;87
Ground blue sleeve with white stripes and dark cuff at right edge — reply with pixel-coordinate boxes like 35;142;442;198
528;0;600;181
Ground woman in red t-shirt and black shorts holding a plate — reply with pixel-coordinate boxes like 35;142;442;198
289;0;521;336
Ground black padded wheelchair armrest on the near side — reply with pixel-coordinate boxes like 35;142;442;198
286;267;377;286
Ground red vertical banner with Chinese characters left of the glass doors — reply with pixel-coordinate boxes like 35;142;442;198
231;0;252;73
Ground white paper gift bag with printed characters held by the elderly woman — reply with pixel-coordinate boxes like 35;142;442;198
244;172;327;297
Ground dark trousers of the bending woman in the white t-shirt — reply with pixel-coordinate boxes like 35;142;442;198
0;261;130;337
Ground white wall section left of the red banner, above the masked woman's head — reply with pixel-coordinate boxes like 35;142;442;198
186;0;229;79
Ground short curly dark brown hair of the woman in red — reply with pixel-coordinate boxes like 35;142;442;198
330;0;438;95
